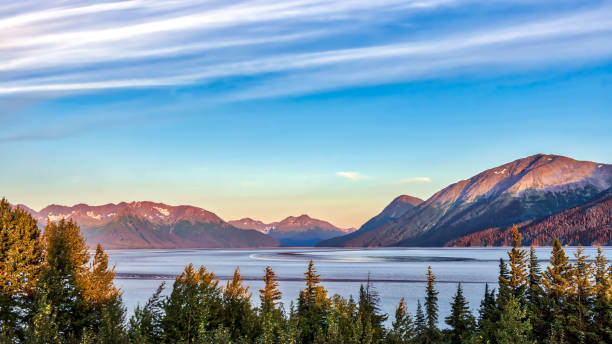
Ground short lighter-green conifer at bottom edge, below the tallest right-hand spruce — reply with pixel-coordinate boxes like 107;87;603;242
495;295;531;344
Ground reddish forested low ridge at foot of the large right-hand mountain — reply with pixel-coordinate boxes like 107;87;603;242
447;189;612;247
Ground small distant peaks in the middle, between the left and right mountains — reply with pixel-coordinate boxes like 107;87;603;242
229;215;354;246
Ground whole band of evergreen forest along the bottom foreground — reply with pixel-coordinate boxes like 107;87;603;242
0;200;612;344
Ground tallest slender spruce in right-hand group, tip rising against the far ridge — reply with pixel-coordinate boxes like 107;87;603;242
500;225;528;305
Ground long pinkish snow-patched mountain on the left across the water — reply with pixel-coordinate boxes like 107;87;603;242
20;202;278;249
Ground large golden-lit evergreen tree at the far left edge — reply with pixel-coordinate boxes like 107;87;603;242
0;199;43;337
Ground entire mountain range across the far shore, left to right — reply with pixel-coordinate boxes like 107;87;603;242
11;154;612;249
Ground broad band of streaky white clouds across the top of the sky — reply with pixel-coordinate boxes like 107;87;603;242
0;0;612;99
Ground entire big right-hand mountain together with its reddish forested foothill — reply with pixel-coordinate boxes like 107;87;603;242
318;154;612;247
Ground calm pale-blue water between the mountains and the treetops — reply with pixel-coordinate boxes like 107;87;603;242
108;247;612;323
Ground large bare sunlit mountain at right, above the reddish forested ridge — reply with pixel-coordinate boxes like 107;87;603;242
319;154;612;246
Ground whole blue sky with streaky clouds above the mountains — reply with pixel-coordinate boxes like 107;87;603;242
0;0;612;227
